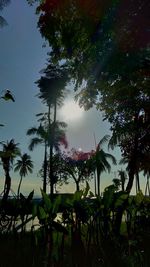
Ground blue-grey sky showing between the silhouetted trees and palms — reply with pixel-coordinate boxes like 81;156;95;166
0;0;146;195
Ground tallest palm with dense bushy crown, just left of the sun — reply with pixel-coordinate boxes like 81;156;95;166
36;62;68;196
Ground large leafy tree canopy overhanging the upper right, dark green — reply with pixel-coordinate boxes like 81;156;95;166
29;0;150;193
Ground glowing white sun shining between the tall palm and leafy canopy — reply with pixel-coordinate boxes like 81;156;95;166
60;100;84;121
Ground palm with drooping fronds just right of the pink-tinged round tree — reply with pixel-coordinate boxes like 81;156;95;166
91;135;116;196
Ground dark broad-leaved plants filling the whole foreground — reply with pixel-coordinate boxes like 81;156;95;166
0;184;150;267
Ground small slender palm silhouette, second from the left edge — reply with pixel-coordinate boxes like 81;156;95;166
14;153;33;197
